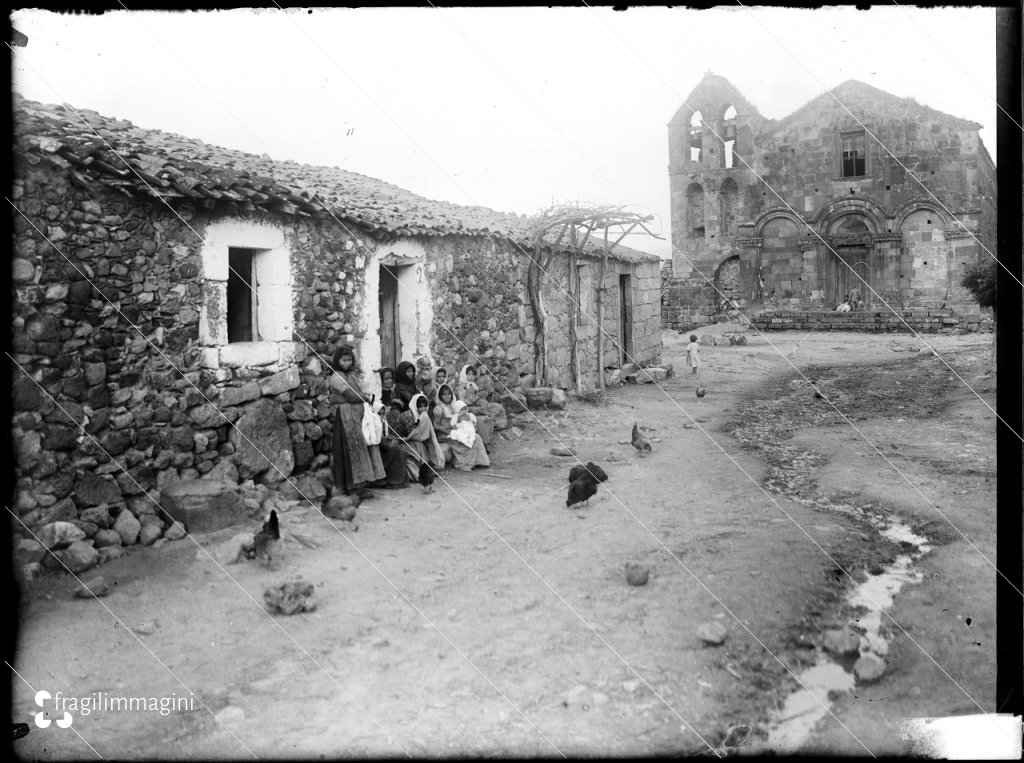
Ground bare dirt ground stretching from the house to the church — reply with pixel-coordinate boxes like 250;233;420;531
13;325;995;759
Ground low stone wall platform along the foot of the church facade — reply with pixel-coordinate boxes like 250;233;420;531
753;309;992;334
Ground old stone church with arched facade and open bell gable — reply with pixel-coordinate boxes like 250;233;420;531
663;72;996;328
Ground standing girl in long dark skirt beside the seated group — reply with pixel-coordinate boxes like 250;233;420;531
329;344;387;495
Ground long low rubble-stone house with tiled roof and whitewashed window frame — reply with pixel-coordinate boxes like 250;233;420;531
11;96;660;523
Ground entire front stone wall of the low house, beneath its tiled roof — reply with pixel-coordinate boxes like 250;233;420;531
11;156;660;543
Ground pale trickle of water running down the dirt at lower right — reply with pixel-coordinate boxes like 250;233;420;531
767;507;932;753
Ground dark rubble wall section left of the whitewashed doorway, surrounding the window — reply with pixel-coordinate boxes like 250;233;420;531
12;157;364;544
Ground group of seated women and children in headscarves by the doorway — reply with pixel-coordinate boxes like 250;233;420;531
378;356;490;479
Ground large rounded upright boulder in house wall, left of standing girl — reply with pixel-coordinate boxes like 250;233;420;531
230;397;295;482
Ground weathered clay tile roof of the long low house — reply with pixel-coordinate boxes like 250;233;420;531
13;93;656;261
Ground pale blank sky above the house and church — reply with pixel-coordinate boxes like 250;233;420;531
11;5;996;257
